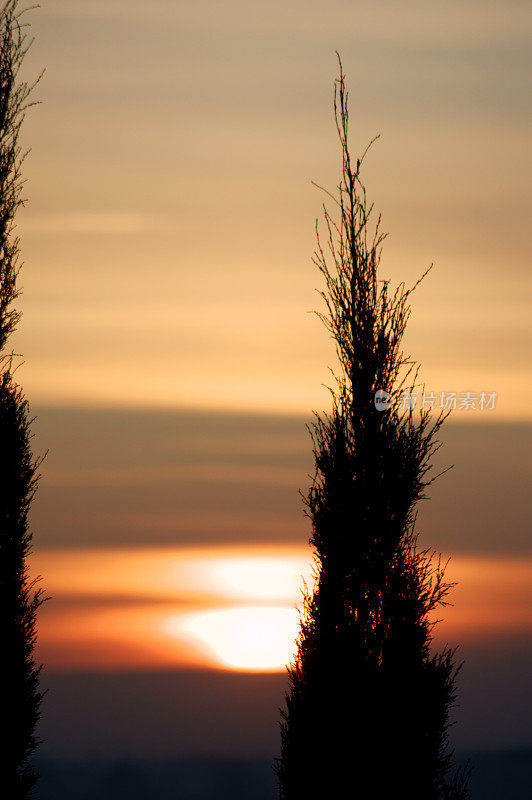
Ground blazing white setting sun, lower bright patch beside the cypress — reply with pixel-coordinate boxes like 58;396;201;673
172;606;299;672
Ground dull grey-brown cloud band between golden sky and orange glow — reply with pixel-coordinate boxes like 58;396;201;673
32;408;532;556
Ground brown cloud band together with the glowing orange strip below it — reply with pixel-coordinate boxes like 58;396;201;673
32;409;532;671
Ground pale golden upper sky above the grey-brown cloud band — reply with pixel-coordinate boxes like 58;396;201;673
11;0;532;418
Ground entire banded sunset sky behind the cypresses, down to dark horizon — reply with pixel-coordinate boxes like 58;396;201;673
6;0;532;768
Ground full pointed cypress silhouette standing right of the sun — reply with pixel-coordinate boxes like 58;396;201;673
276;57;469;800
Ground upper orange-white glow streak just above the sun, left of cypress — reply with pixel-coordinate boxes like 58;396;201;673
33;546;312;604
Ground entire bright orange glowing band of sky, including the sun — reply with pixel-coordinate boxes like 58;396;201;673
33;545;532;672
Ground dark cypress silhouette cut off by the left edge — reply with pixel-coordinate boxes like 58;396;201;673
0;0;43;800
